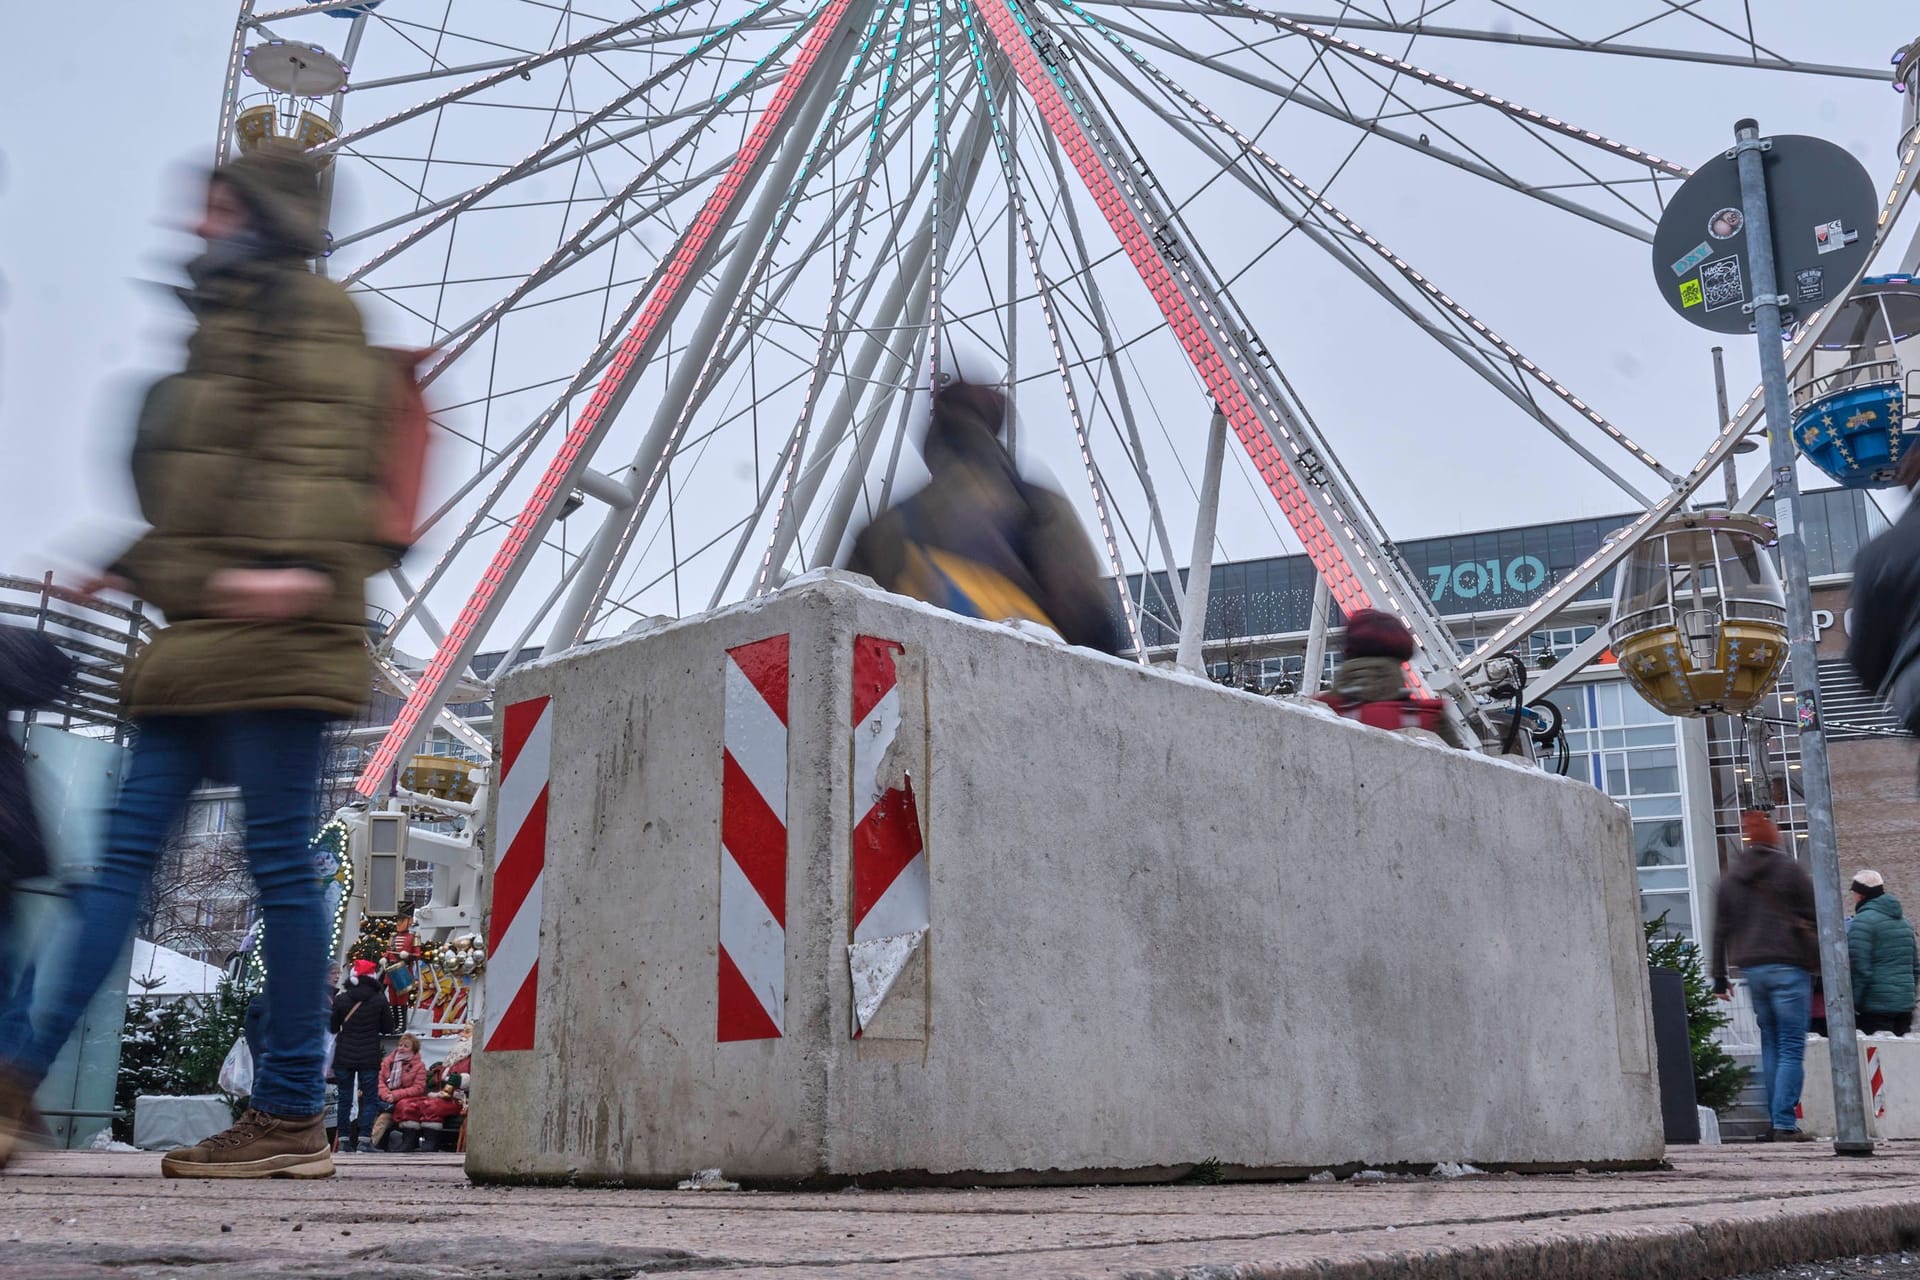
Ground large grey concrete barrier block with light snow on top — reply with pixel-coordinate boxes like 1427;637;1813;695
468;578;1661;1186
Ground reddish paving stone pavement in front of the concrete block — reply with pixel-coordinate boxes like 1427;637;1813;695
11;1144;1920;1280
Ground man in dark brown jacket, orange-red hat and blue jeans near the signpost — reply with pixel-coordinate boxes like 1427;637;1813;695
1713;810;1820;1142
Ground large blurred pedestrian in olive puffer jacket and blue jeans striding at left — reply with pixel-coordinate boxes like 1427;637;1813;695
0;150;396;1178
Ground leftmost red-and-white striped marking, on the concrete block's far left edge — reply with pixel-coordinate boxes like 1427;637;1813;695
482;697;553;1054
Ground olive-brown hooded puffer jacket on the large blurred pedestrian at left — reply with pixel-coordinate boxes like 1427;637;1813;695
113;152;396;718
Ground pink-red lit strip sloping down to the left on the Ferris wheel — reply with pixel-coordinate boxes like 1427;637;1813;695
353;0;852;796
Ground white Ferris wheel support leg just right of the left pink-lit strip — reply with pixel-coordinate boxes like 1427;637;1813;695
545;10;871;652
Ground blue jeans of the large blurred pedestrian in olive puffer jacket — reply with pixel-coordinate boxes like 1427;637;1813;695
0;710;326;1117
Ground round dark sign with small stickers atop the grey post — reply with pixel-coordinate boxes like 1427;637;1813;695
1653;134;1880;334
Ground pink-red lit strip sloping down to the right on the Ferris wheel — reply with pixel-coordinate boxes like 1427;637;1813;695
977;0;1373;614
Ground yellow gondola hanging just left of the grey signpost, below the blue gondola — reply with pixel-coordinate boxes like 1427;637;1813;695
1609;510;1788;716
